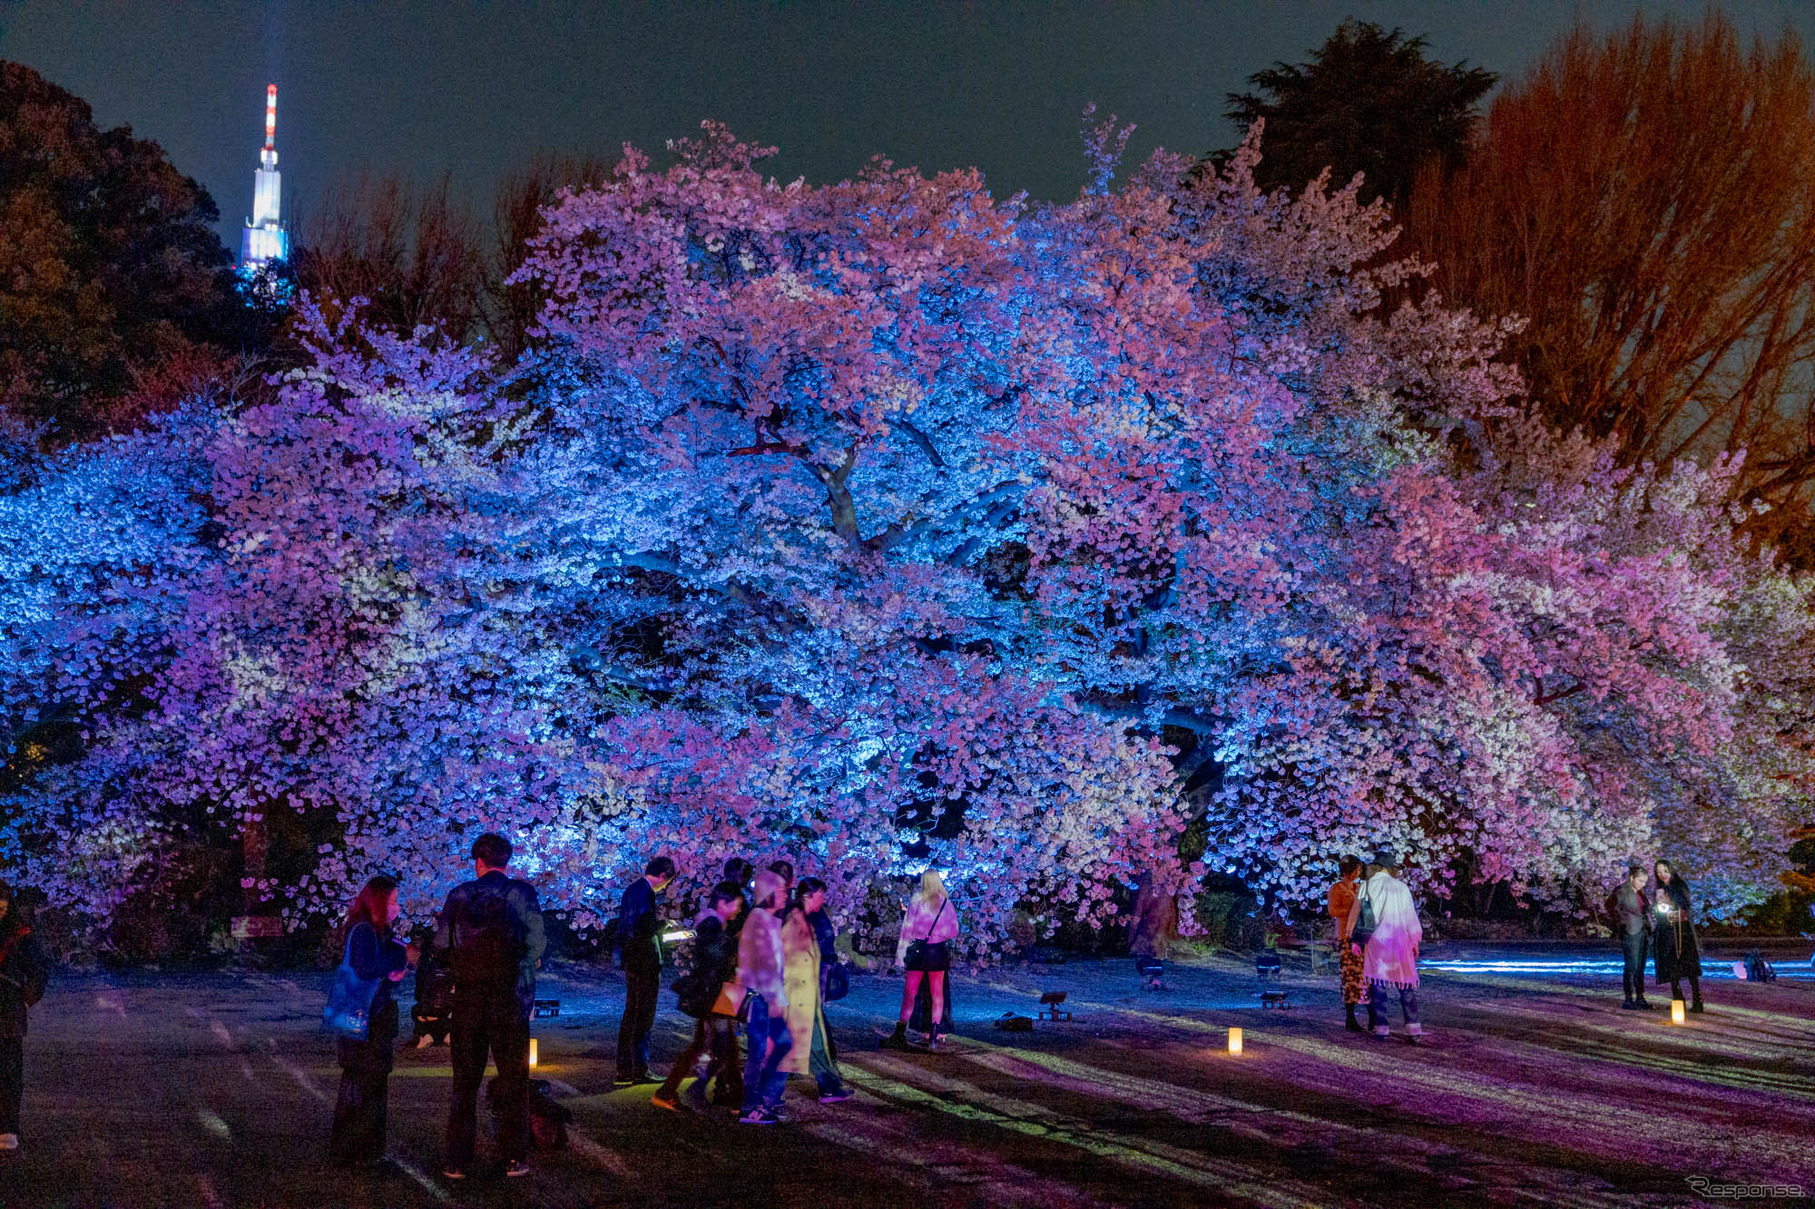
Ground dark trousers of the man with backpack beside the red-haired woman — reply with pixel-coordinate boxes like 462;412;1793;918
446;984;530;1167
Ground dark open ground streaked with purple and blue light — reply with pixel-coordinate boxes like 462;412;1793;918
0;949;1815;1209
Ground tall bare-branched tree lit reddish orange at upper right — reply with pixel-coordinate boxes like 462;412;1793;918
1407;15;1815;561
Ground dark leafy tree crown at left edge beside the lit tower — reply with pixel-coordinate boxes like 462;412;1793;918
0;62;256;441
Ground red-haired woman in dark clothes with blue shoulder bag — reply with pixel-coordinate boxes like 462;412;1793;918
323;877;417;1167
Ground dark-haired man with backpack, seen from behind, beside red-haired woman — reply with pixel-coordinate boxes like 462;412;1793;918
434;831;548;1180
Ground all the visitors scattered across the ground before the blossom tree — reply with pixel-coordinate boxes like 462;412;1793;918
0;833;1727;1180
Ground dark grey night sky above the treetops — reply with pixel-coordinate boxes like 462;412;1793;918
0;0;1815;251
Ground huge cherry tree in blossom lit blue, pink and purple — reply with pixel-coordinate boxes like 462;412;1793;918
0;123;1815;955
